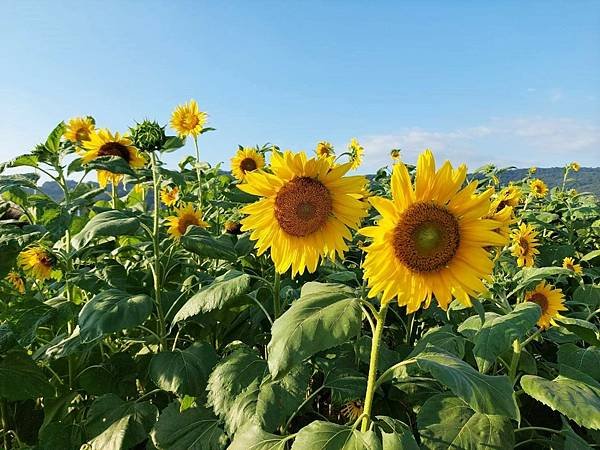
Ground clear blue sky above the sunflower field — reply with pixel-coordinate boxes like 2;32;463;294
0;0;600;172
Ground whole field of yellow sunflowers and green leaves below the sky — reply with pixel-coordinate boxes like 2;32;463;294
0;100;600;450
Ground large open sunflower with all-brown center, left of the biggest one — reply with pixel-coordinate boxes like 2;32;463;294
239;150;367;277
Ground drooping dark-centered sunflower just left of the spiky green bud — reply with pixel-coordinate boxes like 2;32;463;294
81;129;146;187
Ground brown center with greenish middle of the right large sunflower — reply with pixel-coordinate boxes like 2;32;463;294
393;202;460;272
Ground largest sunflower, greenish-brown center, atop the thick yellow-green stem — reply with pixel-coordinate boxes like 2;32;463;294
360;150;507;313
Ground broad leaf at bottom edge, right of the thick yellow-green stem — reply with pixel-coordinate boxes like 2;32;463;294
417;394;515;450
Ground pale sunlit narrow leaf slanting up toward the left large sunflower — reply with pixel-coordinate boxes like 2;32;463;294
173;270;252;323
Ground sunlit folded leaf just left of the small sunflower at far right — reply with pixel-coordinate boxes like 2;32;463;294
473;302;541;373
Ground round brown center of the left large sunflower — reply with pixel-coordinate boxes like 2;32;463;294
275;177;332;236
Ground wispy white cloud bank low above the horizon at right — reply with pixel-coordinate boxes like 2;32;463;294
363;117;600;170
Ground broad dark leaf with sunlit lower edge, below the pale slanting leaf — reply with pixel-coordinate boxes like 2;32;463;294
149;342;217;396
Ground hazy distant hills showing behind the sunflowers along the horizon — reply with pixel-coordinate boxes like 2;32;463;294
37;167;600;200
